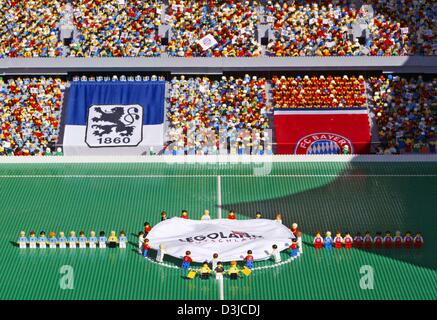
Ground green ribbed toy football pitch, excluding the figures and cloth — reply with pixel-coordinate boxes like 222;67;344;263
0;162;437;300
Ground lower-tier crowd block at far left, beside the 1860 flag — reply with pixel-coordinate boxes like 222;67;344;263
0;77;65;156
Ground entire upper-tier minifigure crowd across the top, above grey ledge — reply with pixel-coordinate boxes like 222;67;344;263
0;0;437;58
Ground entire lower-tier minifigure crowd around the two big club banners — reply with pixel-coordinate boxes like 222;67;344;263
0;74;437;156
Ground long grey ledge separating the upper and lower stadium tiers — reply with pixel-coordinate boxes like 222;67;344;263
0;56;437;75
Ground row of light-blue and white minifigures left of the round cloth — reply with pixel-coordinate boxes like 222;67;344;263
17;231;128;249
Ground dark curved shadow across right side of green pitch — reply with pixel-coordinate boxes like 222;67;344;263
222;162;437;270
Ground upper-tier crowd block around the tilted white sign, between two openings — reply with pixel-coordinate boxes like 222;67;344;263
167;0;261;57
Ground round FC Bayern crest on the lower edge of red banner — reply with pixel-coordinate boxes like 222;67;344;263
294;132;354;154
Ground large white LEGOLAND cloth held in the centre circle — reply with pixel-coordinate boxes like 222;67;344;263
147;218;294;262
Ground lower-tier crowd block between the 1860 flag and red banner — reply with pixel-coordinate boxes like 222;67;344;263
166;75;271;155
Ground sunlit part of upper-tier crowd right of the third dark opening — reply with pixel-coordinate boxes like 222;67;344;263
266;1;415;56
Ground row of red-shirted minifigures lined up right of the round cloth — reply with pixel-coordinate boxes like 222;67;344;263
313;231;424;249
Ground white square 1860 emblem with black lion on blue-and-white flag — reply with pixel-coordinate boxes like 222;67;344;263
85;104;143;148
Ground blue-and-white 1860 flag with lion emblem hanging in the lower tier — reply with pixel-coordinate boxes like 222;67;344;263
63;81;165;155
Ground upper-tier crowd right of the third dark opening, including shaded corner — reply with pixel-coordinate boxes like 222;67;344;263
266;0;430;56
